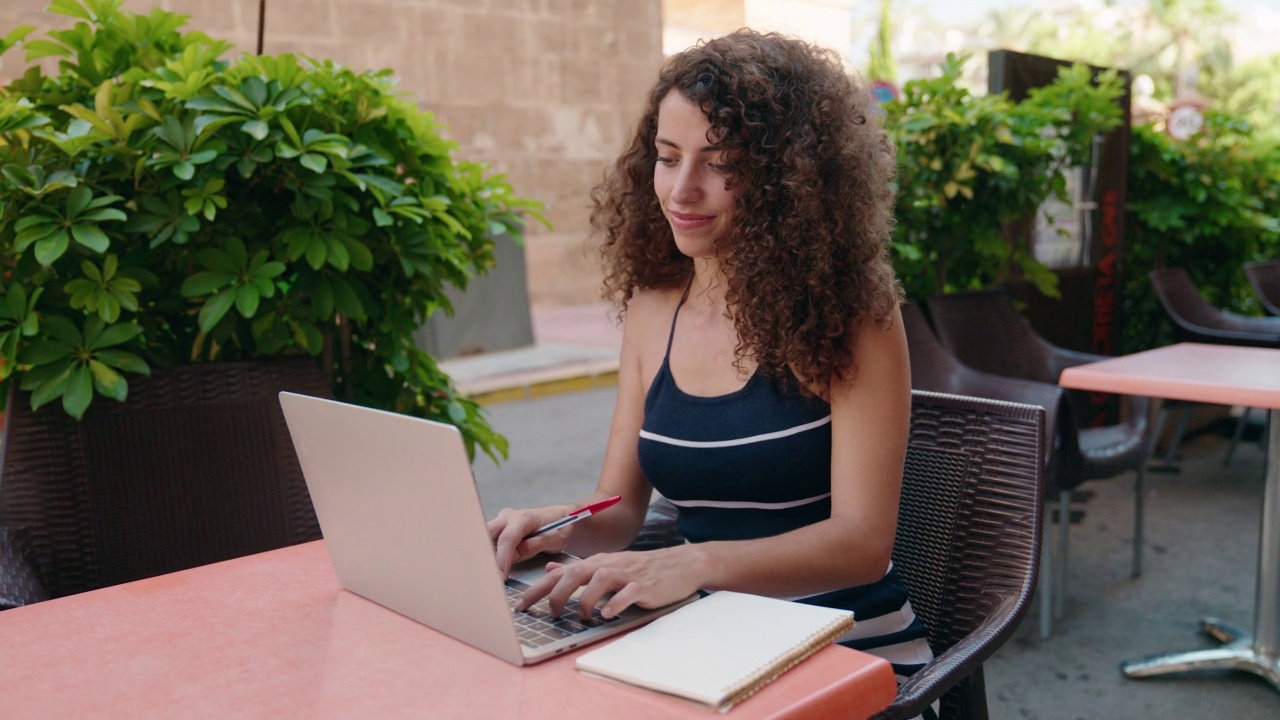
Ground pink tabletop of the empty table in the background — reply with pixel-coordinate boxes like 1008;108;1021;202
1059;342;1280;409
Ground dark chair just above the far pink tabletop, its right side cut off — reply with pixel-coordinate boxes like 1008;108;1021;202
1147;268;1280;347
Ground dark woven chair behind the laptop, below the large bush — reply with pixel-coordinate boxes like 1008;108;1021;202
0;359;330;606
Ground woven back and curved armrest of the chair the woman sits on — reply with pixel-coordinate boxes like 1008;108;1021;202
883;391;1046;717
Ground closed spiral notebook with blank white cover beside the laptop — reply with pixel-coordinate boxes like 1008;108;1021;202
577;591;854;712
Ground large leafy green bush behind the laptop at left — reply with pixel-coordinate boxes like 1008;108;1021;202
0;0;541;459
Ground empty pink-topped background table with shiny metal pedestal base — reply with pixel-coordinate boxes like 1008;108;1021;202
1059;343;1280;688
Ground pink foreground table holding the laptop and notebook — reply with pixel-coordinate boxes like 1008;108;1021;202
0;542;896;720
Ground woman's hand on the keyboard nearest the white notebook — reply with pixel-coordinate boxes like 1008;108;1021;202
517;544;700;618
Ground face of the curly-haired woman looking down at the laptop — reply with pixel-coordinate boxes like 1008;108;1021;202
653;91;737;258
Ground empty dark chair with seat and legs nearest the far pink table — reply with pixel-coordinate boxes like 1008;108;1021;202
929;290;1151;615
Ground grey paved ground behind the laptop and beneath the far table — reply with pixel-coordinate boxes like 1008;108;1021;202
475;388;1280;720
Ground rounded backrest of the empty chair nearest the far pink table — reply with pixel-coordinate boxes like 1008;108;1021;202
929;290;1057;383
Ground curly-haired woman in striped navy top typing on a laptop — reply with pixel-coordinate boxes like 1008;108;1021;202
489;31;931;675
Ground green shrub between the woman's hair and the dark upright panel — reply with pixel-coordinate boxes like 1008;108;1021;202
884;55;1123;300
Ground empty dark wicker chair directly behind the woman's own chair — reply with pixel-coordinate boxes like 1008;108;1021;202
902;304;1084;639
